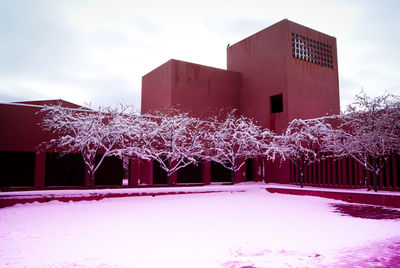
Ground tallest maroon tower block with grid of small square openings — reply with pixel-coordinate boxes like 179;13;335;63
227;19;340;133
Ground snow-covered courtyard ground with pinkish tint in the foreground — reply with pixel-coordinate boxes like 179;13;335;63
0;184;400;268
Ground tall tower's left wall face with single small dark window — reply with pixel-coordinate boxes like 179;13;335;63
227;19;288;132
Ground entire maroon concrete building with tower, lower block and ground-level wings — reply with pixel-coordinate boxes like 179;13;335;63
0;20;400;190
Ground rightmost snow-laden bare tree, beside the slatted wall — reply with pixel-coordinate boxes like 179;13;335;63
329;91;400;191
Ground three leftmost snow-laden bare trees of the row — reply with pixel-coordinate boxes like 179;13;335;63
41;106;273;186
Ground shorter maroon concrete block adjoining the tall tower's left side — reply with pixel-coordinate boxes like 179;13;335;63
141;60;241;118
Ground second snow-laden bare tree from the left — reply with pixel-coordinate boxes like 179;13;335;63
127;110;204;183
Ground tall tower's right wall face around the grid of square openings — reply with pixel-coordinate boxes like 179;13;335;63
285;22;340;121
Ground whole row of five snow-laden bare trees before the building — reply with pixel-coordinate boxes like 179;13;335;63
42;92;400;190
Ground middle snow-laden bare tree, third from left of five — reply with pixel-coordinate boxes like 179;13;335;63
204;111;262;179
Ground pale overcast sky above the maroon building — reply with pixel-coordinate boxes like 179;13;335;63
0;0;400;111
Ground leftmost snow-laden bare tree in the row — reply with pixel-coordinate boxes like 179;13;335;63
41;106;128;187
